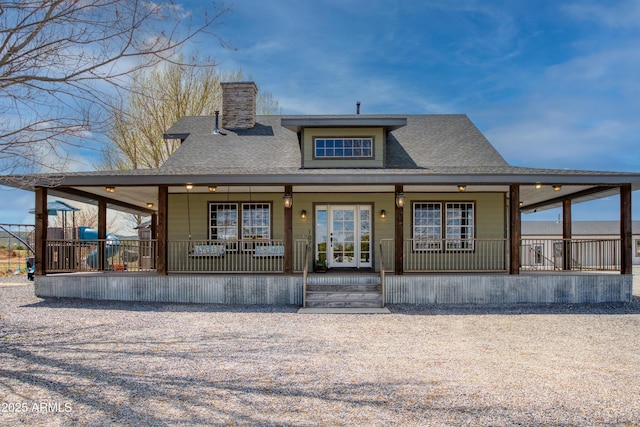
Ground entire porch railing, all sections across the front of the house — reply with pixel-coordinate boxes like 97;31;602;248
45;239;621;273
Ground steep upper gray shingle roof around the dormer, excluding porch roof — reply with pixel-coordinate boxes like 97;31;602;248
160;114;508;170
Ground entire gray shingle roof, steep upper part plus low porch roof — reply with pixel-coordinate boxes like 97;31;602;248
5;115;640;191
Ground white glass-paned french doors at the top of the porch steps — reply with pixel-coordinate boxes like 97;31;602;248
316;205;371;268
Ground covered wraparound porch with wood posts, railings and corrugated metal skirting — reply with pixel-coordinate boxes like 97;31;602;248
23;177;633;306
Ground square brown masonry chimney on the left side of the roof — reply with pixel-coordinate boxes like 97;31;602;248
220;82;258;129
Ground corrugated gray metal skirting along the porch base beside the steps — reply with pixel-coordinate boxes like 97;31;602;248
35;271;633;306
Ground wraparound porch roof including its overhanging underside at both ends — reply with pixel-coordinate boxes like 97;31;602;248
0;166;640;214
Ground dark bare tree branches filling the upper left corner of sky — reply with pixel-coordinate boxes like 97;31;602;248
0;0;229;177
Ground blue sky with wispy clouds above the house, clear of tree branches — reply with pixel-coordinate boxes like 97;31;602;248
0;0;640;226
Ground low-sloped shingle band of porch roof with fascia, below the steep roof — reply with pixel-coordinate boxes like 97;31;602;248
5;165;640;185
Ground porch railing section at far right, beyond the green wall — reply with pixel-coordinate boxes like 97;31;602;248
520;239;621;271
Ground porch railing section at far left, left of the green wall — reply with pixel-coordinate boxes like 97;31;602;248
46;239;156;273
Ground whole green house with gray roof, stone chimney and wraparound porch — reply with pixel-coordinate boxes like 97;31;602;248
2;82;640;307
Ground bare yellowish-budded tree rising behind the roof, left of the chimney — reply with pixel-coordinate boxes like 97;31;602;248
98;58;280;169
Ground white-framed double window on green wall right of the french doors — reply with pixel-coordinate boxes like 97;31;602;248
413;202;475;251
